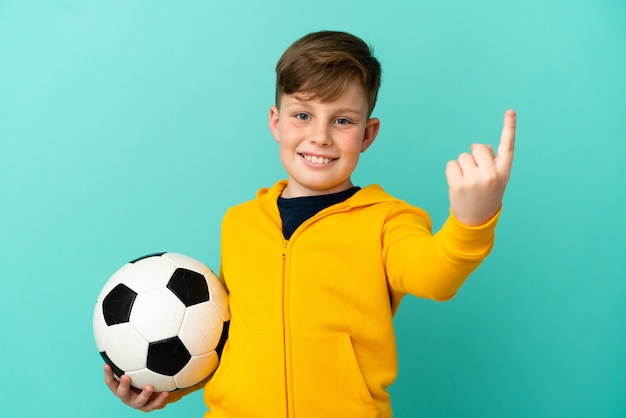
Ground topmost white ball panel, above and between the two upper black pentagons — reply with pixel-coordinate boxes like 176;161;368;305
125;257;176;293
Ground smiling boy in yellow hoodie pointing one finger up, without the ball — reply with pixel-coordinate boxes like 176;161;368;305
105;32;515;418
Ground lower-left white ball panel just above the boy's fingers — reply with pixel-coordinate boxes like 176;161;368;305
104;323;148;371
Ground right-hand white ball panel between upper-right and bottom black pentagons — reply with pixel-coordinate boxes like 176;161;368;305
178;302;224;356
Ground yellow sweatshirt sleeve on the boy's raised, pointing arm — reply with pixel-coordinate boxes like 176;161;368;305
383;205;501;301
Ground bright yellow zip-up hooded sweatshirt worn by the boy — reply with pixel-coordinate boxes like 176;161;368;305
205;182;498;418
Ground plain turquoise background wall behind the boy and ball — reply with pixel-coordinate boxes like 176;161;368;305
0;0;626;418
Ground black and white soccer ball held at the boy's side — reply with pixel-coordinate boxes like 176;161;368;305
93;253;230;392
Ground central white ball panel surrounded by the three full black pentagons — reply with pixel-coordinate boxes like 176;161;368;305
130;287;185;342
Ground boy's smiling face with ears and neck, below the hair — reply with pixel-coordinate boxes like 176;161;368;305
269;80;380;198
